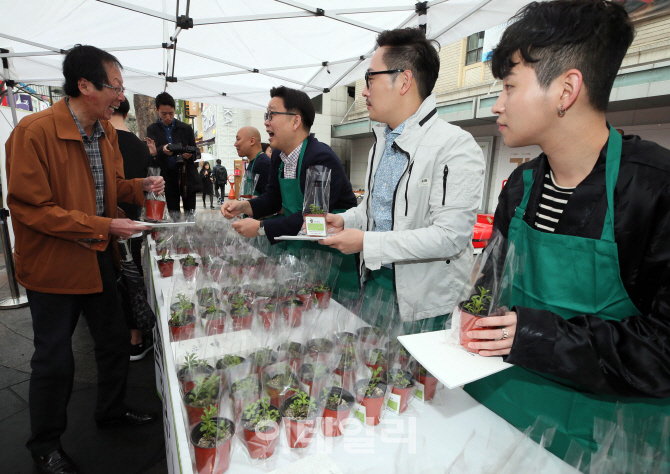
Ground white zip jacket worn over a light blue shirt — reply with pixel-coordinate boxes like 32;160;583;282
341;94;485;321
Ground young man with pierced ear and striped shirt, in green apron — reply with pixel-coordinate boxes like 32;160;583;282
466;0;670;457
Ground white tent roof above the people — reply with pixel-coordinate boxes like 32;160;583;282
0;0;528;108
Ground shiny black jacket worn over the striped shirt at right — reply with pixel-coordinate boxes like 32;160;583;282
493;135;670;398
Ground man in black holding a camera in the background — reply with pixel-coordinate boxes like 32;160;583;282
147;92;202;212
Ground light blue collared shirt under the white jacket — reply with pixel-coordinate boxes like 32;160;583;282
371;122;407;268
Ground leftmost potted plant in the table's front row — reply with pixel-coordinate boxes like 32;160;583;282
191;405;235;474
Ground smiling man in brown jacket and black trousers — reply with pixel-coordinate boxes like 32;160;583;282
6;45;164;474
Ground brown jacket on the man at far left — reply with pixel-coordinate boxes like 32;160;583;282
5;99;144;294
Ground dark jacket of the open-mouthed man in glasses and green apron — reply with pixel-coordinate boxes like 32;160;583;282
249;135;356;244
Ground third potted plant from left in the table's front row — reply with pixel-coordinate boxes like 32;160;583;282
280;391;318;448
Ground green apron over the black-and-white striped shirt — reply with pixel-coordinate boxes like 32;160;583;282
465;127;670;458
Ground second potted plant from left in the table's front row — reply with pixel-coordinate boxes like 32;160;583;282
241;398;281;459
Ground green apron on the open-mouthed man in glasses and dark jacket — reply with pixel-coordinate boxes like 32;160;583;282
276;138;359;294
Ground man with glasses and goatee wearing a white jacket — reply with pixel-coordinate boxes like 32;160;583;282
320;28;484;332
